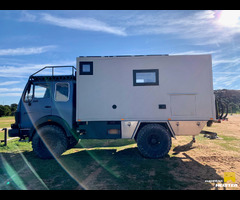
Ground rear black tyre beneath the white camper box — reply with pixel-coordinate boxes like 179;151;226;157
137;124;172;158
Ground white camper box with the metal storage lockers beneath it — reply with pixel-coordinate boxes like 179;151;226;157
76;55;216;138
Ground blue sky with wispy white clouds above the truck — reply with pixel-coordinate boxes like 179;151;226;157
0;10;240;105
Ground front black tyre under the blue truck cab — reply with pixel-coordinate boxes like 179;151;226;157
32;125;68;159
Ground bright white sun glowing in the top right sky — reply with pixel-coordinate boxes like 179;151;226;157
218;10;240;27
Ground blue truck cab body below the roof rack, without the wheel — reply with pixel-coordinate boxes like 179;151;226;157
9;67;75;139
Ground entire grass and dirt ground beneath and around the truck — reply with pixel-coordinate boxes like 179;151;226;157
0;115;240;190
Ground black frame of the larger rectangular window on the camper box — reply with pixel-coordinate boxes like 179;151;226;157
133;69;159;86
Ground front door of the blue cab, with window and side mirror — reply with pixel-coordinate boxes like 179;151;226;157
21;82;52;128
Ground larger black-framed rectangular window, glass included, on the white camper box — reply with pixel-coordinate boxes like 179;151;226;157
133;69;159;86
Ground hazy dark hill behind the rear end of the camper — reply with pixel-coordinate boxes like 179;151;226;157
214;89;240;113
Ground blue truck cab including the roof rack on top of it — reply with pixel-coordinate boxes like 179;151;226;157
9;66;77;158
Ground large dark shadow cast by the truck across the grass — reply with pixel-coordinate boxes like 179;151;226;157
0;140;222;190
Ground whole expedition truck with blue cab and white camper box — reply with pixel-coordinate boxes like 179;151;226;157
9;55;216;159
